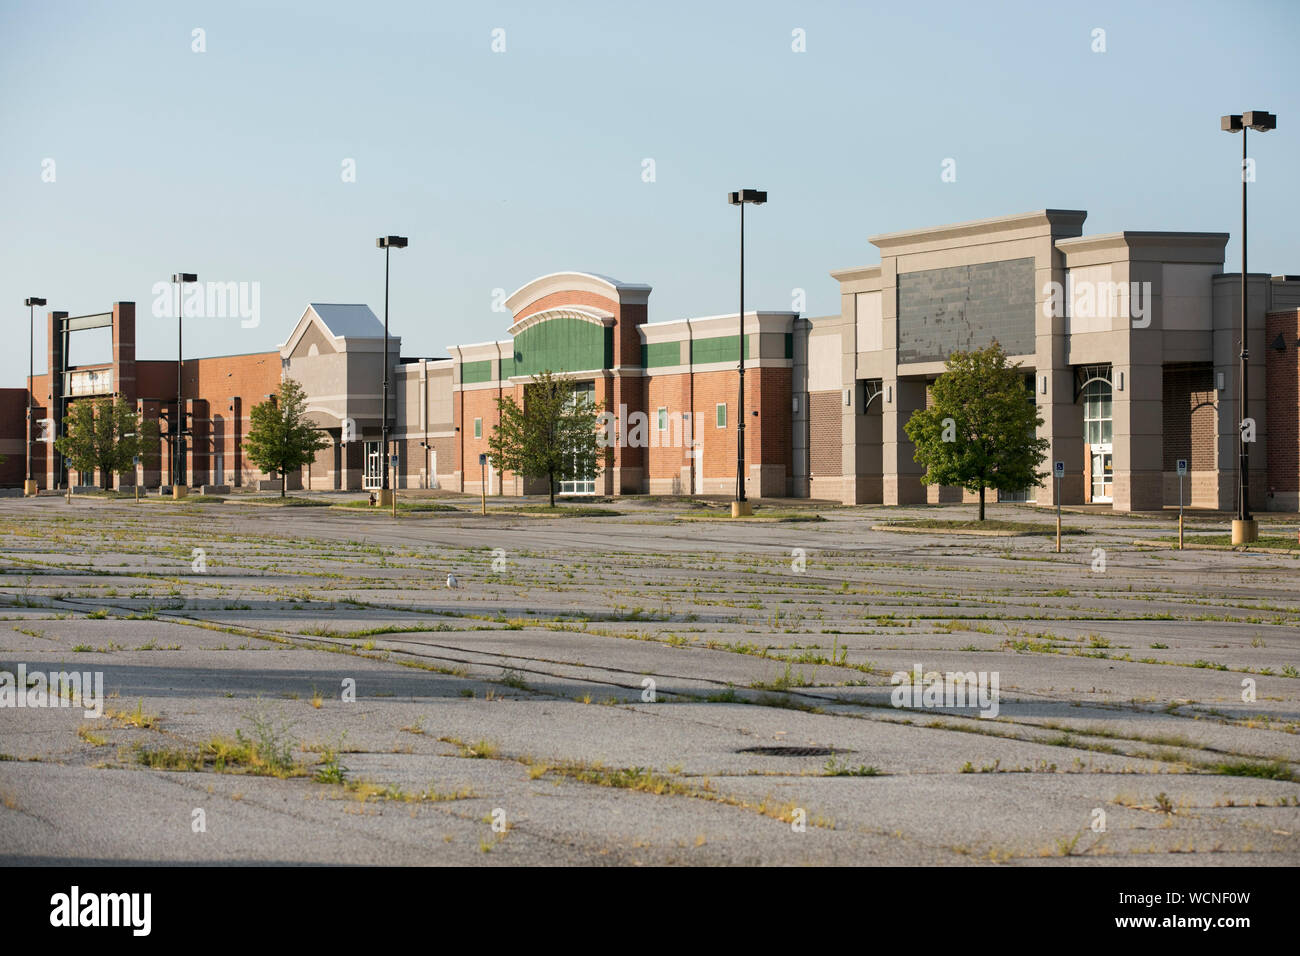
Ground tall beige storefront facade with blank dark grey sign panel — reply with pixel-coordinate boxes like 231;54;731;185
805;209;1300;511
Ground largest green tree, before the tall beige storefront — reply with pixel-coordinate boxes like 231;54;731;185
905;341;1048;522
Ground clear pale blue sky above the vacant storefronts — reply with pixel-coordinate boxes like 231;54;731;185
0;0;1300;386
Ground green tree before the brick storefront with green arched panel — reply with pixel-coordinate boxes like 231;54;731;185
488;369;601;507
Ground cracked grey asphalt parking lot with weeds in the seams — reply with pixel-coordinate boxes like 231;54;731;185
0;497;1300;866
